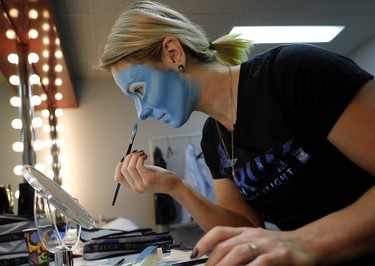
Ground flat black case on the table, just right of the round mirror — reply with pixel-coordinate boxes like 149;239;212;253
81;229;173;260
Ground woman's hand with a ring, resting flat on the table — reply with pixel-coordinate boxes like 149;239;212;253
195;226;316;266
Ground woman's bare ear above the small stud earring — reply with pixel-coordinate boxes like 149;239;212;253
161;36;186;71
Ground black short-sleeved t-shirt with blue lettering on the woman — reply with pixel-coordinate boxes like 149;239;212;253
201;45;375;230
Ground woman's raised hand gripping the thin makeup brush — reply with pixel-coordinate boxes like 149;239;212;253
114;151;181;194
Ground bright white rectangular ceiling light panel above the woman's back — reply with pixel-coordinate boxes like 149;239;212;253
230;26;345;43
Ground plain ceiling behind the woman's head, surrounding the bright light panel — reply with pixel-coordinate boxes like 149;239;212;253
51;0;375;80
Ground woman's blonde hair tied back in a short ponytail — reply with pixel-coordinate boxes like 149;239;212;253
99;1;252;70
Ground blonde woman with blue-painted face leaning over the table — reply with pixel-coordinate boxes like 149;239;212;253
100;1;375;266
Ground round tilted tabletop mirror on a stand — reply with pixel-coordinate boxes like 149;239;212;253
23;165;95;266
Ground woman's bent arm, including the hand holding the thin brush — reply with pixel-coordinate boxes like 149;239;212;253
114;151;263;231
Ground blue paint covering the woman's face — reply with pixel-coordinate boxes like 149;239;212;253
113;64;199;127
